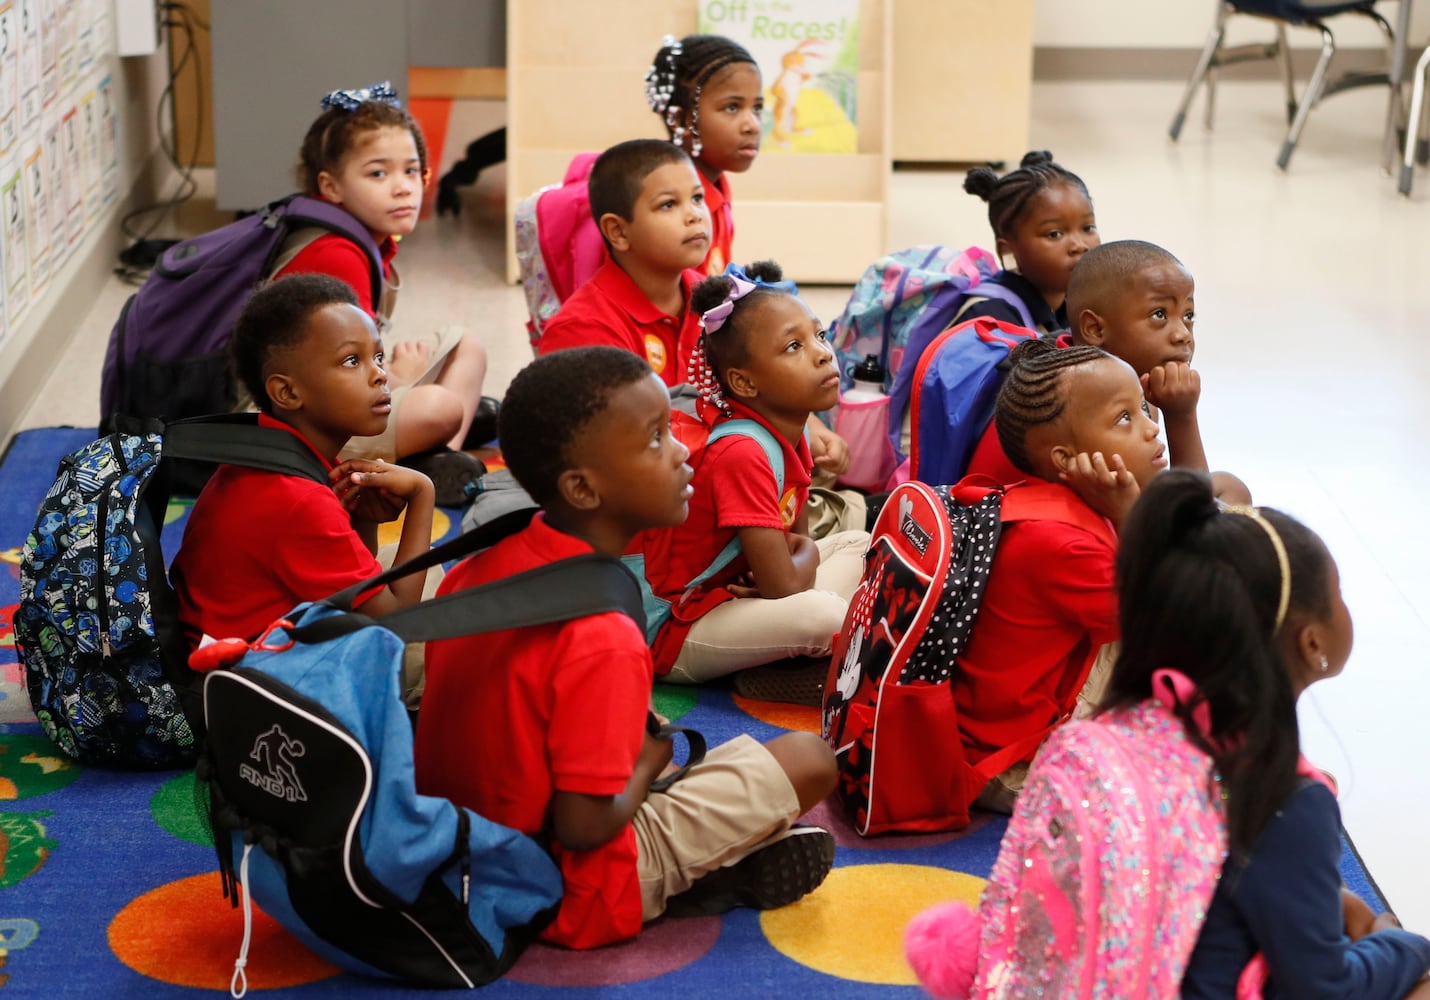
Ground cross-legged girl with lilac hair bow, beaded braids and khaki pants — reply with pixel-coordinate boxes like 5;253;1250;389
646;262;869;704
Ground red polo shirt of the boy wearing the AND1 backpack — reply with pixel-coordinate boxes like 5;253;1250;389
416;515;651;948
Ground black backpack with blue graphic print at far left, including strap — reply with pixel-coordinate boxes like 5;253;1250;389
14;415;327;768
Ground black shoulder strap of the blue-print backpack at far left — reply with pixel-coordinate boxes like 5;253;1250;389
147;413;327;486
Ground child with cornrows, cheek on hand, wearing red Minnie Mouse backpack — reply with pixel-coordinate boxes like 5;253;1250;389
954;340;1167;811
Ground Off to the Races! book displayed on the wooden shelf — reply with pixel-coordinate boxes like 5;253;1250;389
699;0;859;153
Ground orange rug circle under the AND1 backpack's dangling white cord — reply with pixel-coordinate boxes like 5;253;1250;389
109;871;342;991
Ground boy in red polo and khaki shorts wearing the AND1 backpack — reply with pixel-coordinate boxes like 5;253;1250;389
416;346;834;948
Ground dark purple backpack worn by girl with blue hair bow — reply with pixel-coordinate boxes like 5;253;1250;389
99;195;383;421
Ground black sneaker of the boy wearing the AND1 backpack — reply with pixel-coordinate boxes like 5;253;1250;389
665;823;834;917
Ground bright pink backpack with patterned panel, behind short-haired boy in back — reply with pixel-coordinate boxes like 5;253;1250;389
513;153;606;351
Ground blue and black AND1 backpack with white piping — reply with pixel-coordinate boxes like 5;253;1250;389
196;511;641;996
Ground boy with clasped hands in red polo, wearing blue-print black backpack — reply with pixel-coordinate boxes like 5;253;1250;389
170;275;433;694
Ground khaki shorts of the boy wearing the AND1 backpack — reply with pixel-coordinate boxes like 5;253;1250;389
631;735;799;920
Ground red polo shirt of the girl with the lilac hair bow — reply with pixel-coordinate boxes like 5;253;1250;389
644;403;814;674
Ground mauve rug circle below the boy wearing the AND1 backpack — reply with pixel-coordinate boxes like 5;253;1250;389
506;917;721;986
